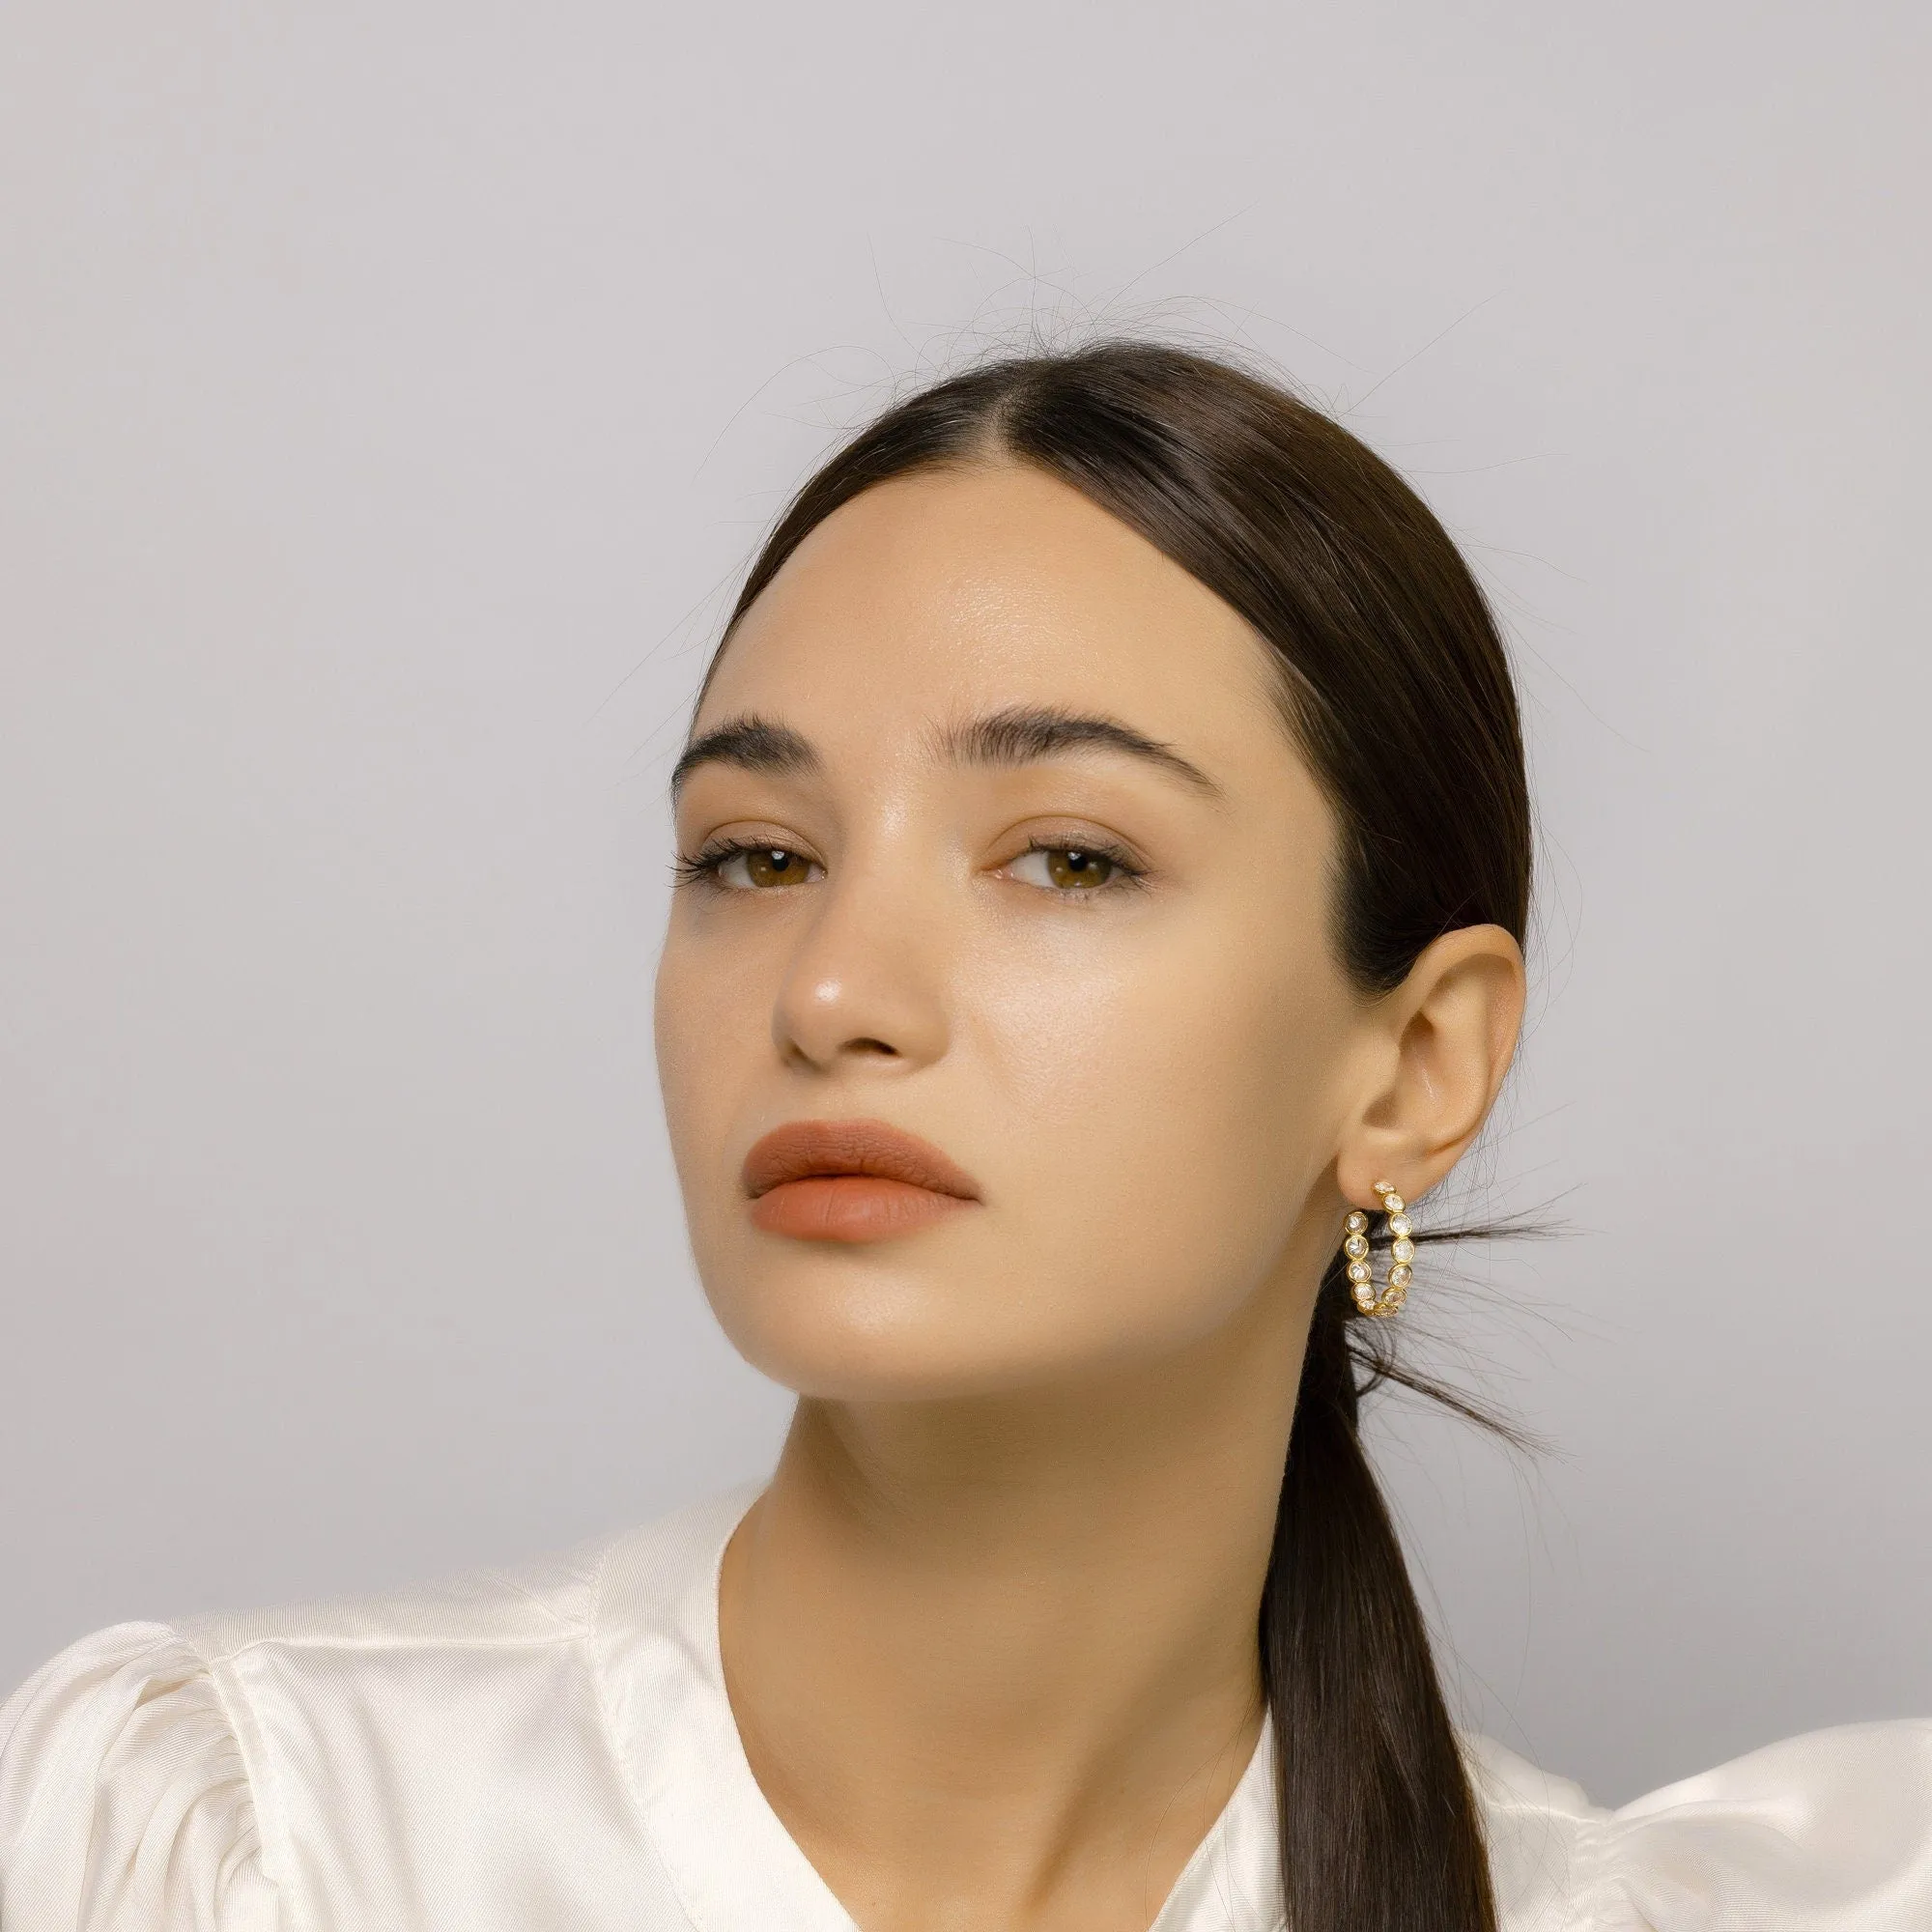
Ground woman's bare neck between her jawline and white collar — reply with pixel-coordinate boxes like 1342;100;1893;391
719;1252;1308;1932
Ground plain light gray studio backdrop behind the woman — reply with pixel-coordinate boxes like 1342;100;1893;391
0;0;1932;1801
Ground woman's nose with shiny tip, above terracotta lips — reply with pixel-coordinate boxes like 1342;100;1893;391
771;852;949;1072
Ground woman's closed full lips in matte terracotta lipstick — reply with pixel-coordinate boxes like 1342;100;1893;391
744;1121;980;1242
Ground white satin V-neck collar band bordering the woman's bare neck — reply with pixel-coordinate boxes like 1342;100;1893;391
593;1484;1283;1932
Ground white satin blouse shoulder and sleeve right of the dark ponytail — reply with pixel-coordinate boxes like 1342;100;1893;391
1472;1719;1932;1932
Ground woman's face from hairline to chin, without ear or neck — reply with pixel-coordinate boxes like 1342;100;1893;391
657;466;1360;1401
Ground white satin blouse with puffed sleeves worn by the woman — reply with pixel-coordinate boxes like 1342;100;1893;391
0;1488;1932;1932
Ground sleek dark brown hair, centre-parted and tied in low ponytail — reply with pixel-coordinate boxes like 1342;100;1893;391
705;342;1530;1932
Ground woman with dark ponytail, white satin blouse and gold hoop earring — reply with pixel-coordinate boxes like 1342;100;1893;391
0;344;1932;1932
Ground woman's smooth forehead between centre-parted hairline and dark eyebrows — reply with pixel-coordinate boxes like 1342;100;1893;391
696;466;1285;763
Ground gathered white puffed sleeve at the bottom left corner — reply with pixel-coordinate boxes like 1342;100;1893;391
0;1623;276;1932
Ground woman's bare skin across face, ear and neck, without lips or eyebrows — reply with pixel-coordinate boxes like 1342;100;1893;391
657;464;1524;1932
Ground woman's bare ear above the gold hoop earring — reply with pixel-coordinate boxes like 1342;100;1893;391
1335;925;1526;1208
